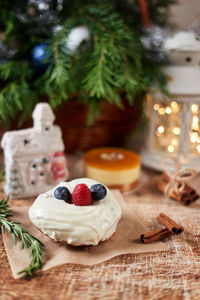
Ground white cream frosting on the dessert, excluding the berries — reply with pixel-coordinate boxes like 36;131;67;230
29;178;121;246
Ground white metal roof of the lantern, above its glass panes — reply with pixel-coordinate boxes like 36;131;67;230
163;31;200;68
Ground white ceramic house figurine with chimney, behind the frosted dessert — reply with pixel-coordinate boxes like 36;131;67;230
1;103;68;198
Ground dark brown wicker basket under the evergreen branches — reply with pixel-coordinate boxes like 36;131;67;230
56;101;139;152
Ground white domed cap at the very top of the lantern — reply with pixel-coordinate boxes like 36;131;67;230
163;31;200;51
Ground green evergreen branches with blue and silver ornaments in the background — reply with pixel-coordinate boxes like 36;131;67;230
0;0;175;123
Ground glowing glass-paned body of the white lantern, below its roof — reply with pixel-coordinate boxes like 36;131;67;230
145;93;200;170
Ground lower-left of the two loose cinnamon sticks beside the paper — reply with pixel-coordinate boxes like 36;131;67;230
140;228;174;244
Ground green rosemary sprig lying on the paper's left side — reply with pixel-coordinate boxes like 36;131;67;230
0;198;43;277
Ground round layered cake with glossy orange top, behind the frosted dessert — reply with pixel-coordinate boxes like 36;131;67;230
84;147;140;192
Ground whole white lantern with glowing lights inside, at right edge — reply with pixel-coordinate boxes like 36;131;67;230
142;33;200;171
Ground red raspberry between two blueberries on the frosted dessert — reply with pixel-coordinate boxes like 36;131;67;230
72;183;92;206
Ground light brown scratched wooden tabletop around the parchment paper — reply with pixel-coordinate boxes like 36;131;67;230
0;162;200;300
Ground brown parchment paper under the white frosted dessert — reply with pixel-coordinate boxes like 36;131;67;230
3;190;168;278
